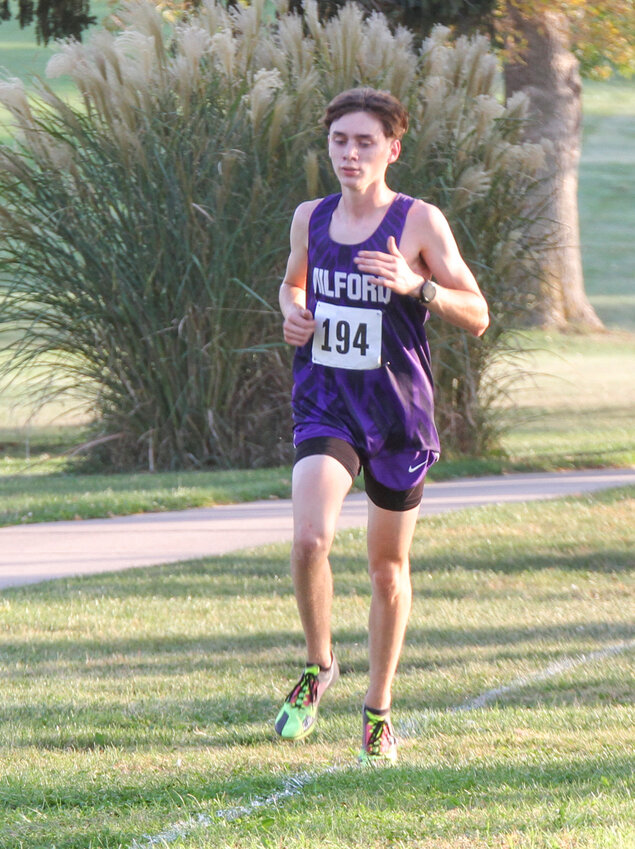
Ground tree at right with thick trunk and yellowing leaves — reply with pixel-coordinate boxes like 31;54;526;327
497;0;635;329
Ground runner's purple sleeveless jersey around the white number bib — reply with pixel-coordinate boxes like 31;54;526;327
292;194;439;458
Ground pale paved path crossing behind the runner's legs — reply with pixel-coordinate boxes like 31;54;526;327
0;469;635;588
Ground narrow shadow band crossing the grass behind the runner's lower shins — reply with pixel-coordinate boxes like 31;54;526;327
0;620;635;672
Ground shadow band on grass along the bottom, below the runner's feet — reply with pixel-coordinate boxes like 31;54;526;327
0;753;633;849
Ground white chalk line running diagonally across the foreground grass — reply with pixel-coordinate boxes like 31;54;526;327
130;640;635;849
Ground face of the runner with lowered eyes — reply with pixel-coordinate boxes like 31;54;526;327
329;112;401;191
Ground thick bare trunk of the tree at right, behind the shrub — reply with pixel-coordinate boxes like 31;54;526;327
504;9;603;329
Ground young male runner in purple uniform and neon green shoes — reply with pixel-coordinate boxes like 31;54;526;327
275;88;489;764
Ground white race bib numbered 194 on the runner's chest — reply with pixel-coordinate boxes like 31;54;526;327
312;301;382;371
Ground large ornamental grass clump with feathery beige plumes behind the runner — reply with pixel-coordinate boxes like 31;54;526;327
0;0;541;469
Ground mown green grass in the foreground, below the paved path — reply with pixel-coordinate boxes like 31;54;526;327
0;488;635;849
